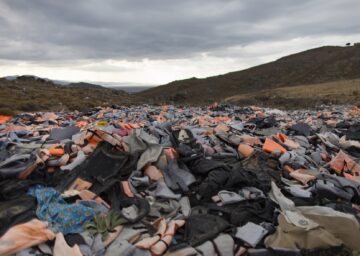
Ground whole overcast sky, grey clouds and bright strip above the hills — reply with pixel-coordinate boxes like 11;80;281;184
0;0;360;85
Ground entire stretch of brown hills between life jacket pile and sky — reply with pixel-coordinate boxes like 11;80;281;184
0;46;360;114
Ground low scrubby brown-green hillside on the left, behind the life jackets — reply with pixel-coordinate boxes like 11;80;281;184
0;76;132;114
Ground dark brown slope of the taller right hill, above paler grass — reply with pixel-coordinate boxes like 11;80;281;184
138;46;360;104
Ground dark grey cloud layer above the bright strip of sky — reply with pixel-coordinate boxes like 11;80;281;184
0;0;360;62
